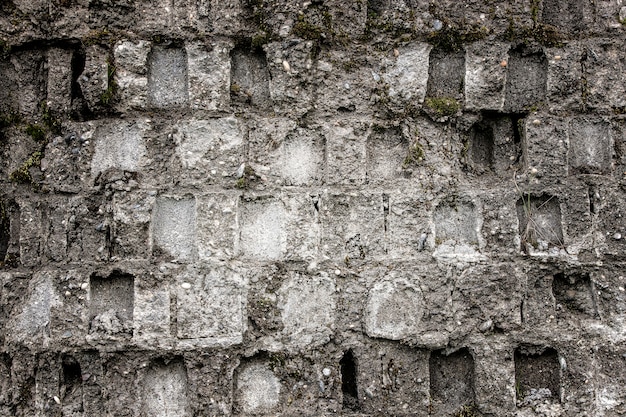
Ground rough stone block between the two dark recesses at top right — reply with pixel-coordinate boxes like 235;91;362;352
465;42;510;110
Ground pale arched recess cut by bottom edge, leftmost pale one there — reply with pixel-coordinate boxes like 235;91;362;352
142;360;191;417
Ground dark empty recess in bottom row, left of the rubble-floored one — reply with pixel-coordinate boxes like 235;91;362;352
429;349;475;415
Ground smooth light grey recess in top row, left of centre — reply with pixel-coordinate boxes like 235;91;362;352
148;46;189;108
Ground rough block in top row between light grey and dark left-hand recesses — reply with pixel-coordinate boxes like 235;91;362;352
185;42;232;110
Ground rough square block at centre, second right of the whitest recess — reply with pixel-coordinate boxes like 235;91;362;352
320;192;385;261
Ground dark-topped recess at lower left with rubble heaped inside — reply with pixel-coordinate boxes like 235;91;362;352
89;272;135;335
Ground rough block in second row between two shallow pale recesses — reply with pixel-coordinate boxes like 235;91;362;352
325;121;369;184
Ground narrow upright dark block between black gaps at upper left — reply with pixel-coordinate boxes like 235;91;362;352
46;48;74;114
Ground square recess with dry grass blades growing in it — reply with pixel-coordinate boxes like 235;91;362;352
517;194;563;250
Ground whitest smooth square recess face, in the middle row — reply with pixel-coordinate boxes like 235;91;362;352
239;199;287;259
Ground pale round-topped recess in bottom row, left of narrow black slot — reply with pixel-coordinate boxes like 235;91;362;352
236;362;282;415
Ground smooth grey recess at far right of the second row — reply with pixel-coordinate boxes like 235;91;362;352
568;118;612;174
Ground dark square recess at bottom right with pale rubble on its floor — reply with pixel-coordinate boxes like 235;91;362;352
515;346;561;405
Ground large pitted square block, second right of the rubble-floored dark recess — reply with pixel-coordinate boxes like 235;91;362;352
174;264;247;349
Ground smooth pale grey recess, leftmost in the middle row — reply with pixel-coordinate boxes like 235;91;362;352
151;195;198;261
